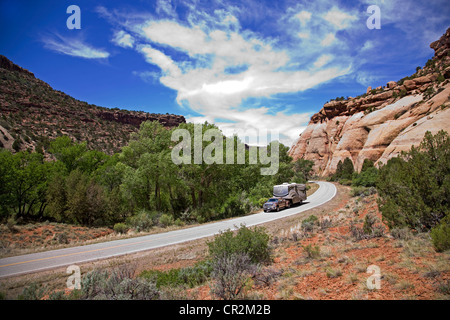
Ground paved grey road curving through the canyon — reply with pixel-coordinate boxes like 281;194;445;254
0;181;336;278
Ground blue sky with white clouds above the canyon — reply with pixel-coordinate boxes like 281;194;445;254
0;0;450;145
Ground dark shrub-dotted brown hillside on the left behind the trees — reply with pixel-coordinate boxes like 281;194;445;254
0;55;186;154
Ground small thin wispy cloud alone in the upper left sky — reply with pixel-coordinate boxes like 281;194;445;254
42;35;109;59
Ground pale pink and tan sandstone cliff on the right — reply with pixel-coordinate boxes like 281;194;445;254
289;28;450;176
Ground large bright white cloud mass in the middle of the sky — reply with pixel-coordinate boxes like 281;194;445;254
115;3;350;145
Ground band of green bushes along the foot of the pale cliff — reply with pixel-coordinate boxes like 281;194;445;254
329;130;450;251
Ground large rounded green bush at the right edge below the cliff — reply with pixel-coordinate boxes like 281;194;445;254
377;131;450;231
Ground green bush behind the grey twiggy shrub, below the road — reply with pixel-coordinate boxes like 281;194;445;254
207;226;271;263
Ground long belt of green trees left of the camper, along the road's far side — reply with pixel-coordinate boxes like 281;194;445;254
0;121;313;233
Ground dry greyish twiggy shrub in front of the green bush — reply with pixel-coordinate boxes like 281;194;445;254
211;253;257;300
